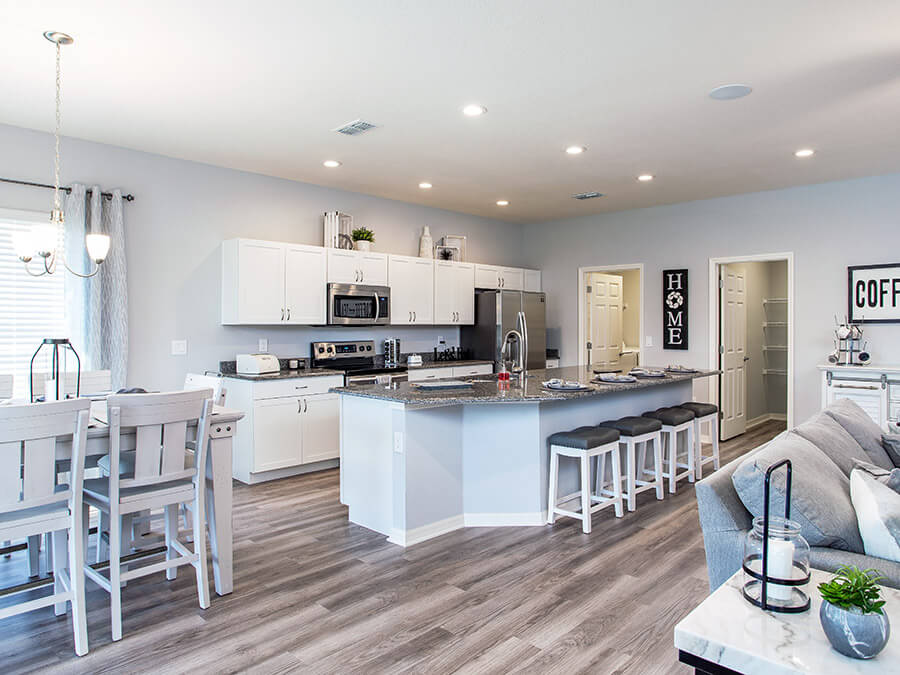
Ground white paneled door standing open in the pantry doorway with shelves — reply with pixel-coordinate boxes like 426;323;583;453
719;265;747;440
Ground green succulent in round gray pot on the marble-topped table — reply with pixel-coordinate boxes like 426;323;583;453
819;565;891;659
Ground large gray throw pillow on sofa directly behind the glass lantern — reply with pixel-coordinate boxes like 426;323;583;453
731;432;863;553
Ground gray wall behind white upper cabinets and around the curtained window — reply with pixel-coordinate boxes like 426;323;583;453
0;125;523;388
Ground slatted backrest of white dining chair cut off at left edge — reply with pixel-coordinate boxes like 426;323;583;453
0;399;91;513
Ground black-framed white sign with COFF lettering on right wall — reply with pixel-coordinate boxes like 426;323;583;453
847;263;900;323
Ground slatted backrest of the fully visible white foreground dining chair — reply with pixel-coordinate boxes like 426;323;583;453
107;389;213;498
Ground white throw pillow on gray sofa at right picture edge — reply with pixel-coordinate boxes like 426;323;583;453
850;469;900;562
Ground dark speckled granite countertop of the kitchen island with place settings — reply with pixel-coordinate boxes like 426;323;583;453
332;366;719;408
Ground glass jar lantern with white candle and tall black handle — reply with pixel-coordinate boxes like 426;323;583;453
742;459;810;613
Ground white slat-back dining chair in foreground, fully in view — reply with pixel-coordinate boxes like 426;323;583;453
83;389;213;640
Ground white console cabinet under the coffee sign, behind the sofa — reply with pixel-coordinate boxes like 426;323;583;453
819;365;900;429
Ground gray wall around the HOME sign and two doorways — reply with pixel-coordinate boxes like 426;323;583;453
525;175;900;423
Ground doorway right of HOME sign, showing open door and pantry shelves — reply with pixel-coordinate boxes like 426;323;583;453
709;253;794;441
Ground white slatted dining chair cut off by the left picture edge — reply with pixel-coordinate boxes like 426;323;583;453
0;399;90;656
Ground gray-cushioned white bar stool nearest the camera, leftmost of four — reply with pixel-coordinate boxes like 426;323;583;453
547;427;622;534
